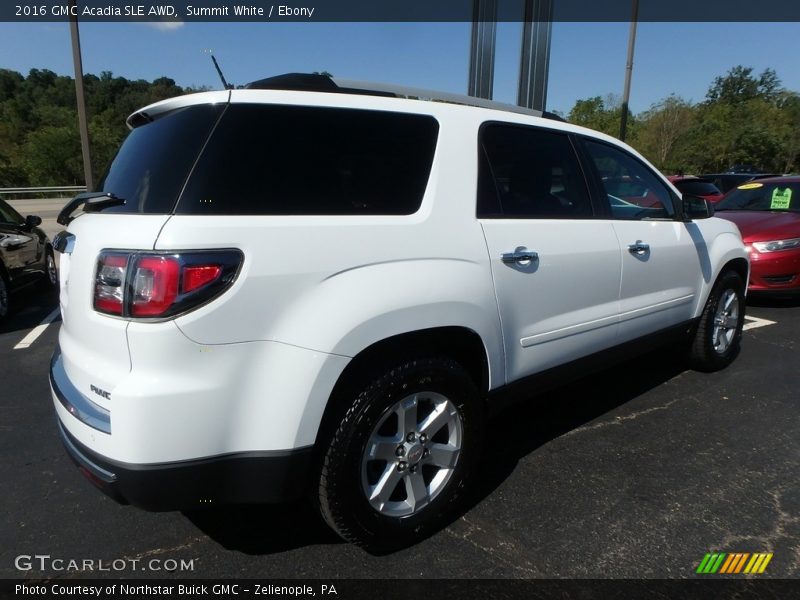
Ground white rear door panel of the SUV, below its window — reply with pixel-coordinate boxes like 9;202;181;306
481;219;620;382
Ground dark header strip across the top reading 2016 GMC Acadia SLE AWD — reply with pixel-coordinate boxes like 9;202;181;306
0;0;800;23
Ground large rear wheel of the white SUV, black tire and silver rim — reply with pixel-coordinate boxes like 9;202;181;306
318;357;483;552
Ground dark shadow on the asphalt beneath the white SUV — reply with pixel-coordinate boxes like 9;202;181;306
184;346;686;555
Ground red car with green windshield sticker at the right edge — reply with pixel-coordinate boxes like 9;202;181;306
714;176;800;294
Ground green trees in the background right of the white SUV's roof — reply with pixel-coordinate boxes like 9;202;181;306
568;65;800;173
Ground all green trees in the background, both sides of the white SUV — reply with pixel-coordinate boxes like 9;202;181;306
0;65;800;187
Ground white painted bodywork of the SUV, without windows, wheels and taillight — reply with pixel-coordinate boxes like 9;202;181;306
54;90;747;478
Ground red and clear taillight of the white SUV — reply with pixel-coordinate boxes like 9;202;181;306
94;250;242;318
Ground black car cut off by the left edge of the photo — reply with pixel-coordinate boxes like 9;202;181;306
0;200;58;319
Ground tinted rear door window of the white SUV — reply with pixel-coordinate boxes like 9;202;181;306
478;124;592;219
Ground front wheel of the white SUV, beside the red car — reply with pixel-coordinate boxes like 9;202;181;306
689;271;745;372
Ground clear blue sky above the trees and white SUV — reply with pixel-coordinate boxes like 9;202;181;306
0;23;800;113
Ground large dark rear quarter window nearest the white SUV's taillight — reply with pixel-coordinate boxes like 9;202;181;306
177;104;439;215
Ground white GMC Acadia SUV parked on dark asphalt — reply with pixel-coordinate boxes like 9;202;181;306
50;76;749;547
